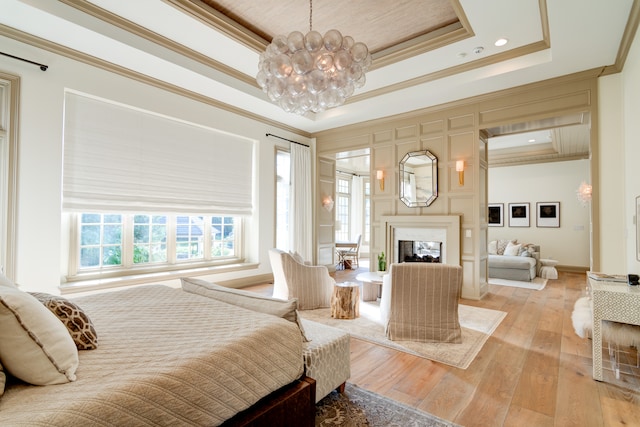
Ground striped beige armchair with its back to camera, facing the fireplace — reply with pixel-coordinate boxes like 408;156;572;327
380;262;462;343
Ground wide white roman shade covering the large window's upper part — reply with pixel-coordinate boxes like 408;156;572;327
63;92;254;215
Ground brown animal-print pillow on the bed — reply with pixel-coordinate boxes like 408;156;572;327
29;292;98;350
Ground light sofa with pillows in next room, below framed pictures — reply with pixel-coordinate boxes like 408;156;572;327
488;240;540;282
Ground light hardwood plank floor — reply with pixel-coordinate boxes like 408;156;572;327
252;268;640;427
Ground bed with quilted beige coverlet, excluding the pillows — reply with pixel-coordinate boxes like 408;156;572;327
0;285;315;427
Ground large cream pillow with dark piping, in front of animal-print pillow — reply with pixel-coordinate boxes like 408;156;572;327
0;286;79;385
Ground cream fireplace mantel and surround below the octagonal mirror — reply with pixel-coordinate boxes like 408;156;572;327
381;215;460;265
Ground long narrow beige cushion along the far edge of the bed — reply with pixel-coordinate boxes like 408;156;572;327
180;277;308;341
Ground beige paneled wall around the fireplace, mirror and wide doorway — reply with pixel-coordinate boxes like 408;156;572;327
315;70;599;299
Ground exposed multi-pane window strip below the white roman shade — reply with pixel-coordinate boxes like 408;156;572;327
70;213;242;278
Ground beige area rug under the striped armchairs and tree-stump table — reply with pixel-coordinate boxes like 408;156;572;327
300;301;507;369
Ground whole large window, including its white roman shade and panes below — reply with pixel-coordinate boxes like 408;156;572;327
62;91;252;281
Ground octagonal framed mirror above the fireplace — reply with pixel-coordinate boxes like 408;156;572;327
400;150;438;208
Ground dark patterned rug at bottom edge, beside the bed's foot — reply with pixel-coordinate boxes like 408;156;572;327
316;383;457;427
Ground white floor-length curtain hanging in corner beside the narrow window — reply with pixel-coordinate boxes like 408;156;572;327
289;144;313;261
